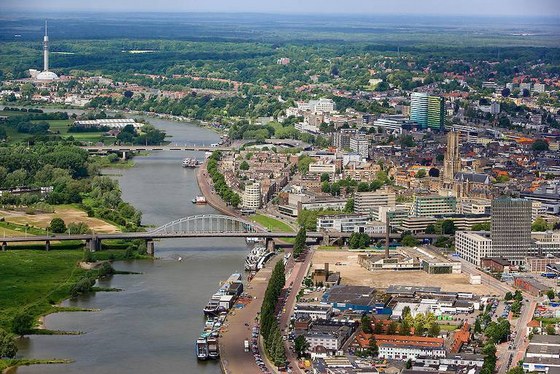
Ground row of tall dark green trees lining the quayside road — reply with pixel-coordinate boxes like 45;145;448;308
260;261;286;367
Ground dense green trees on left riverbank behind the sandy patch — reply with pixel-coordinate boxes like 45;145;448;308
0;143;142;230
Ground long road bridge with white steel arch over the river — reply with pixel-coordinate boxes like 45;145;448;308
0;214;446;255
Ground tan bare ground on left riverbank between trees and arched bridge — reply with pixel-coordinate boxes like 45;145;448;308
0;205;120;236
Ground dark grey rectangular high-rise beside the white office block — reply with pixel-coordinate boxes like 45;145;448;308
490;197;532;265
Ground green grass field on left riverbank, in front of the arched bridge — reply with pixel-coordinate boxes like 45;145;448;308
0;249;85;329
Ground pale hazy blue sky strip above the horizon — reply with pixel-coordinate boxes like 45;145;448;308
0;0;560;17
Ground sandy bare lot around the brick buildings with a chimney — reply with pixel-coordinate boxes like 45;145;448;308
311;250;492;295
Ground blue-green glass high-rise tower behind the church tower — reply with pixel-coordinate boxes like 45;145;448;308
410;92;445;130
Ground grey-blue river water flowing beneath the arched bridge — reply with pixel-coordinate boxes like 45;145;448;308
14;119;246;374
